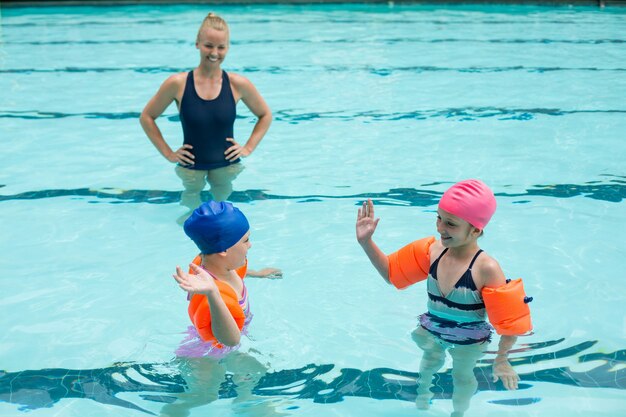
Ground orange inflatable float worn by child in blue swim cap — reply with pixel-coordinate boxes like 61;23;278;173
187;256;248;346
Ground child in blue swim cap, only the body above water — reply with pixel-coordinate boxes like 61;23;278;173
173;201;282;357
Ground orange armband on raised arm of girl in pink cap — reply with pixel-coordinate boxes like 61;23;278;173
387;236;435;289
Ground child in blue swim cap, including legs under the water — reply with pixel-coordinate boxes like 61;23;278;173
165;201;282;416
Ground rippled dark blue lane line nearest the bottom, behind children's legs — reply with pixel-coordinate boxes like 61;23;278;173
0;339;626;414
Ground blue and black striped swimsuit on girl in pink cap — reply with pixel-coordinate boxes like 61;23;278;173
419;248;492;345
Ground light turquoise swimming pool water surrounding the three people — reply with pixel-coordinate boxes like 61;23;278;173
0;5;626;416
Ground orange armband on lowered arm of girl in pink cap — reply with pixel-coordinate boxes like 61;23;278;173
482;278;533;336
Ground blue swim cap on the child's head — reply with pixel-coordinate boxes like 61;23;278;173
183;200;250;255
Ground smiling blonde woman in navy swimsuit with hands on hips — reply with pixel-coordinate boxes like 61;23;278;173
140;13;272;218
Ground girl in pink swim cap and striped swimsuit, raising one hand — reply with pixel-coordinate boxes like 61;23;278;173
356;180;526;417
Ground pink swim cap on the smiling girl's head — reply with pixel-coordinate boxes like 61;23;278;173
439;180;496;229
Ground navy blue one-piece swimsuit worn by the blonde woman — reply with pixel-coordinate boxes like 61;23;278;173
180;71;240;170
